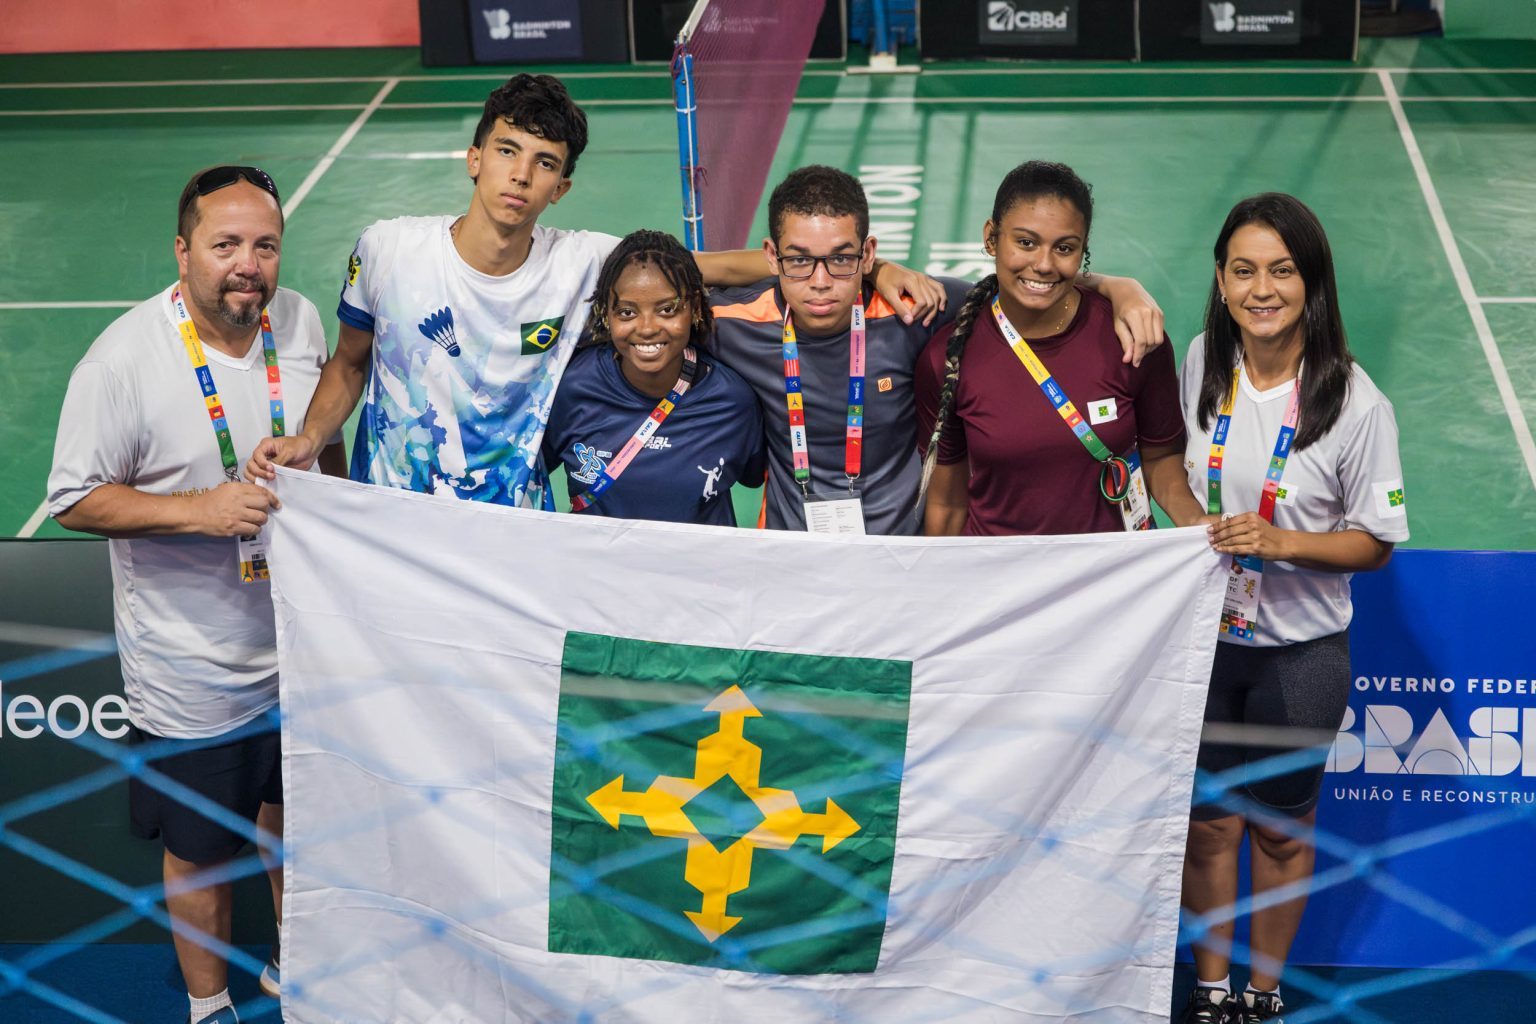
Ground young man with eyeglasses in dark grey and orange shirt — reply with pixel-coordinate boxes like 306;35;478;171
710;166;1163;534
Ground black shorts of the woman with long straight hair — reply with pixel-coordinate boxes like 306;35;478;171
1190;633;1350;821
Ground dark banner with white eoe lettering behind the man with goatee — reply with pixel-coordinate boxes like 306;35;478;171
0;539;273;939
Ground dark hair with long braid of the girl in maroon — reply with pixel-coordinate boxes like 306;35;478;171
917;160;1094;510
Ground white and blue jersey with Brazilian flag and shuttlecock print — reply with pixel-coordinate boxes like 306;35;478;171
336;216;619;508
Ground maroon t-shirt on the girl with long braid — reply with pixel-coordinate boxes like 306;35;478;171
914;289;1184;536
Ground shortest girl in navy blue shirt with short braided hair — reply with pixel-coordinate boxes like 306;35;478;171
544;230;765;527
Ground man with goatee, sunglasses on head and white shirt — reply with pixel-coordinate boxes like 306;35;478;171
48;166;344;1024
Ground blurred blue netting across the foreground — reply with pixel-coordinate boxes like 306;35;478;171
0;620;1536;1024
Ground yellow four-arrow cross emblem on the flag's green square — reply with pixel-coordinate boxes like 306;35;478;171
587;686;859;943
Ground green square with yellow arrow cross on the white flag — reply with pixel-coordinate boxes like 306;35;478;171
548;633;912;975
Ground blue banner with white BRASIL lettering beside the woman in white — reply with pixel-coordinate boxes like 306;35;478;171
1292;551;1536;967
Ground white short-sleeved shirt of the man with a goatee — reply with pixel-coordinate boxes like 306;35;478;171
48;286;326;738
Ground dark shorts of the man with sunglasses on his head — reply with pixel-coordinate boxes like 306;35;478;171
127;720;283;864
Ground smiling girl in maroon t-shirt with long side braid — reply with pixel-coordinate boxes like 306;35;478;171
915;161;1204;536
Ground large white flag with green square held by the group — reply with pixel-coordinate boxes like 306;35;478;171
261;471;1224;1024
